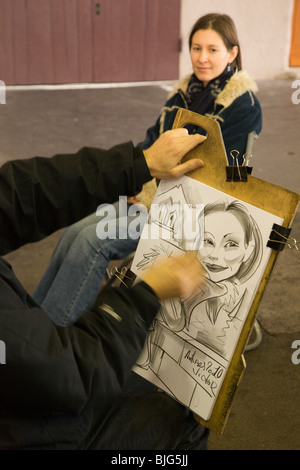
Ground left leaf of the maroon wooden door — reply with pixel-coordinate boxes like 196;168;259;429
0;0;88;85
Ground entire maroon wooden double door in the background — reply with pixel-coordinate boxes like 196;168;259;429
0;0;180;85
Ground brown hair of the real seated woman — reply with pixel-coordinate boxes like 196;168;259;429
189;13;242;70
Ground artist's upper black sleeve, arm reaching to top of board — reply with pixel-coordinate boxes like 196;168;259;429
0;143;151;255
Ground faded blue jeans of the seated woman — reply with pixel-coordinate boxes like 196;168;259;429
33;201;147;326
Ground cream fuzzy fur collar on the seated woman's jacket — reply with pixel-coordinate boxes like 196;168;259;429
171;70;258;108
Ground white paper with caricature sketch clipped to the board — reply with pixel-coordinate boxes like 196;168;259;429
131;176;283;420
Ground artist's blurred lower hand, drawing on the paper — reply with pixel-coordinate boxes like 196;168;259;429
142;252;204;300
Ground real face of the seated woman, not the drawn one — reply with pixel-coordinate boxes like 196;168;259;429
190;29;238;86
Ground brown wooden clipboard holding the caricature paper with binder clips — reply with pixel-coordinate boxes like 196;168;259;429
173;109;300;433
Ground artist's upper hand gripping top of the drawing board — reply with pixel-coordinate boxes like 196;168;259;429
144;128;206;179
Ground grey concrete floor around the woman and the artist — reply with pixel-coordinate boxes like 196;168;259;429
0;81;300;450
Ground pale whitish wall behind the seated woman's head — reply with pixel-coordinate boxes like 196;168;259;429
179;0;300;80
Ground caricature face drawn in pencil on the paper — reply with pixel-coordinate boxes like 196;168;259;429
199;212;253;282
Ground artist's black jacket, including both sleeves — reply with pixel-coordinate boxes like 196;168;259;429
0;143;159;449
